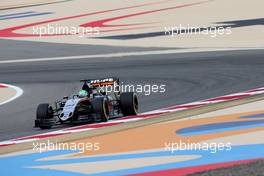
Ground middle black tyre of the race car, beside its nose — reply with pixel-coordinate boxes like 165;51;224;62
92;97;109;122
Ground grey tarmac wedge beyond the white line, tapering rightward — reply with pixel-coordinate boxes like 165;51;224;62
0;39;171;60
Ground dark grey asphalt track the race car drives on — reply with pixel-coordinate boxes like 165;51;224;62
0;40;264;140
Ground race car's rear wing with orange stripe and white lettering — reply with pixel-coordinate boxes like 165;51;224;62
80;77;119;87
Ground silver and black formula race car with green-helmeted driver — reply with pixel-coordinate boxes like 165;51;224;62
35;78;138;129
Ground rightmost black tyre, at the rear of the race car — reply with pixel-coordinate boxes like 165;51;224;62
120;92;138;116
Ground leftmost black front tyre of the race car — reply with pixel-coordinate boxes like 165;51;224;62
35;103;54;129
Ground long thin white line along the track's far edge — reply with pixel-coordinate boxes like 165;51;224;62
0;48;264;64
